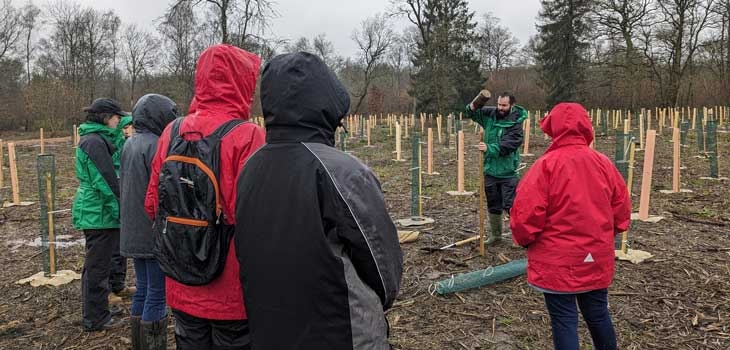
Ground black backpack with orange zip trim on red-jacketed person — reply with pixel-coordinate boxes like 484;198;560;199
153;118;244;285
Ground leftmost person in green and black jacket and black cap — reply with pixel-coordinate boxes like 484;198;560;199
72;98;128;331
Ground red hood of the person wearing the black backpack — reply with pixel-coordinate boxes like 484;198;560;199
189;44;261;120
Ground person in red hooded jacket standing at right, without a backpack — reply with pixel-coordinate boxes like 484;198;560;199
510;103;631;350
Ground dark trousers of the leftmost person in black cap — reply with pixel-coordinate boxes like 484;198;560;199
81;229;119;328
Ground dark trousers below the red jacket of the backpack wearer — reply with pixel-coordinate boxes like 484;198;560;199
172;309;251;350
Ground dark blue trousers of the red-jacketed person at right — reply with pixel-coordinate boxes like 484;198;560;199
545;289;616;350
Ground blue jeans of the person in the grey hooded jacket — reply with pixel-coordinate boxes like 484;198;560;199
131;258;167;322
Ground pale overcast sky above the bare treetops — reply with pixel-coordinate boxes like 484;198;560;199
13;0;540;56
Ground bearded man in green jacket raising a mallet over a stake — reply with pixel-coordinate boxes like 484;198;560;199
466;90;527;244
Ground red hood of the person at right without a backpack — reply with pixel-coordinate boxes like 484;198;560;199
540;102;593;151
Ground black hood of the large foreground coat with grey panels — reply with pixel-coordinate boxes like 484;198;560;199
261;52;350;146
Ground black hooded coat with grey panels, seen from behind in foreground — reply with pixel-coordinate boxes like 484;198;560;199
235;53;403;350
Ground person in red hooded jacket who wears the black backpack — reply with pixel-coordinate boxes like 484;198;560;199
145;44;265;350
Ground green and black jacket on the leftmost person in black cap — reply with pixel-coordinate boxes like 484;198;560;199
72;122;119;230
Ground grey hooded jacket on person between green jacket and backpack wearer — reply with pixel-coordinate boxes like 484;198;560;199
119;94;178;258
